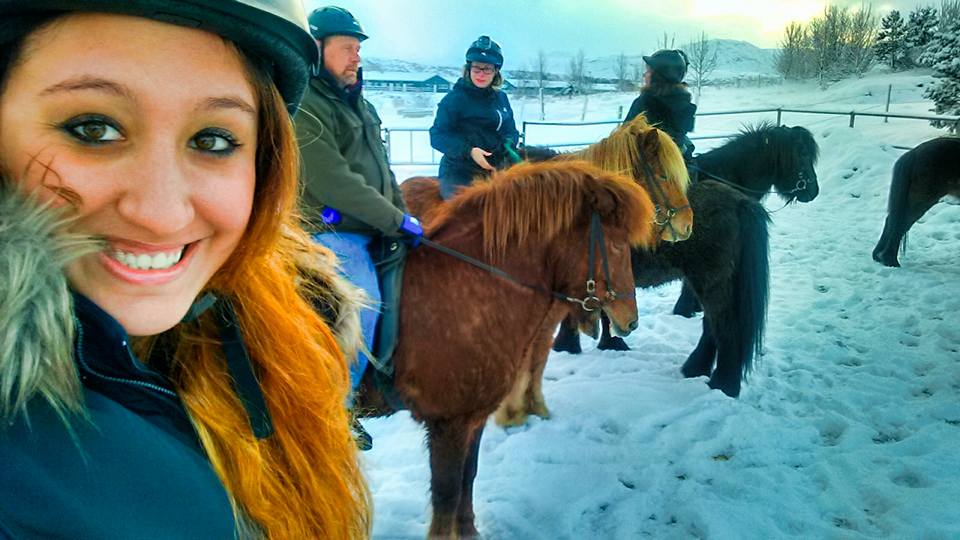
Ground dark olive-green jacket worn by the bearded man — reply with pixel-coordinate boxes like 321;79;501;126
295;72;406;236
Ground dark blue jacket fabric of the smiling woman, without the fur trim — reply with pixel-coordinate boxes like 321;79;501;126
0;296;236;540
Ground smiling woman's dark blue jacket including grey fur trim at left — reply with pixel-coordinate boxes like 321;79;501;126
0;188;236;540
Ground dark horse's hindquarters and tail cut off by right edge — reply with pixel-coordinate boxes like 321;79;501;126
873;137;960;266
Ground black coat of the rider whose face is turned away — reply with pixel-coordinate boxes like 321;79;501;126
624;86;697;160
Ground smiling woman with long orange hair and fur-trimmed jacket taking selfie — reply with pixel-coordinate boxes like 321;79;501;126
0;0;370;538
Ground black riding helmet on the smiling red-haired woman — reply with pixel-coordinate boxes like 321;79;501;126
0;0;319;114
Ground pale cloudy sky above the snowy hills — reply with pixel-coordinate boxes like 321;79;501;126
305;0;939;68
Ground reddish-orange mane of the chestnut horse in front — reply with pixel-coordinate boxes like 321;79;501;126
430;161;654;258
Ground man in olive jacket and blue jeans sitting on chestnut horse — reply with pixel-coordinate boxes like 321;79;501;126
295;6;423;442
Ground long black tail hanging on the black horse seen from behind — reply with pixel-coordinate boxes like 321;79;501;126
733;197;770;379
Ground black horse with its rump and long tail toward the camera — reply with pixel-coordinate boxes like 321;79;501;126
553;180;769;397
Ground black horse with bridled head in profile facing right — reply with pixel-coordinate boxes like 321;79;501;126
673;122;820;317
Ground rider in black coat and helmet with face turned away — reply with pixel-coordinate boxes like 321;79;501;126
623;49;697;161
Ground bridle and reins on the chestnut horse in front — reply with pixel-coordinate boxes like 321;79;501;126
420;211;619;312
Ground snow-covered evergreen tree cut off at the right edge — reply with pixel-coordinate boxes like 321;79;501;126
923;17;960;132
